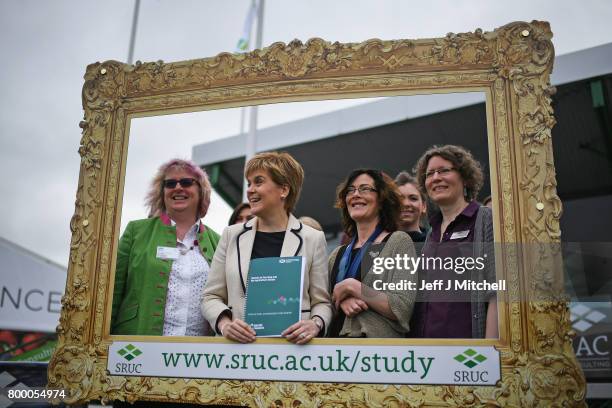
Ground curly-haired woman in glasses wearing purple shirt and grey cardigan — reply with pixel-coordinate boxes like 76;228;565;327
415;145;498;338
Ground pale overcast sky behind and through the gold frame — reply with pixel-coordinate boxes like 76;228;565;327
0;0;612;265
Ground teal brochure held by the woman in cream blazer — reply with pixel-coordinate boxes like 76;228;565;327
244;256;304;337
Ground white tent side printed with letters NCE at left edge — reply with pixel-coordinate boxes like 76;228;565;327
0;237;67;333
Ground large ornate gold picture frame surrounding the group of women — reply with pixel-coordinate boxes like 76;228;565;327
49;21;586;407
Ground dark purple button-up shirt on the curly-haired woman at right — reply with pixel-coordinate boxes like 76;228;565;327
411;201;480;338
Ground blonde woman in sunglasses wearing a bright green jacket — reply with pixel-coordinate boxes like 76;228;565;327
111;159;219;336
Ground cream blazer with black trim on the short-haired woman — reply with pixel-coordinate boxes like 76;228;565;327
202;214;332;334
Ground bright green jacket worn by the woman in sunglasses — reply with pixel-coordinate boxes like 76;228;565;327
111;214;219;336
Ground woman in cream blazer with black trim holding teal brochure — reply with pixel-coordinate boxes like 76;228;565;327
202;152;332;344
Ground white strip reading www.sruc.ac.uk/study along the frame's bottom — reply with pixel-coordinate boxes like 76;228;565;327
107;341;501;385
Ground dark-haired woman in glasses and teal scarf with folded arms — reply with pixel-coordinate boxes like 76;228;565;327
328;169;418;337
